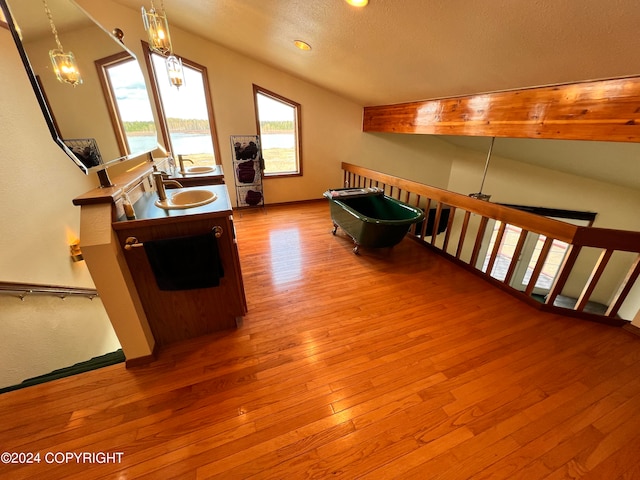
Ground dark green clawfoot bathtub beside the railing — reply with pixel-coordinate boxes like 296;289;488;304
323;188;424;253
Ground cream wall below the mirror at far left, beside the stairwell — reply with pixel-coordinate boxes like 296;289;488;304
0;28;120;387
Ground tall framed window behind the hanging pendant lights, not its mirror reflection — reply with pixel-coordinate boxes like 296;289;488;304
143;42;220;165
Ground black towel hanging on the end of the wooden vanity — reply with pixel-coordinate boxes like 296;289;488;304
144;233;224;290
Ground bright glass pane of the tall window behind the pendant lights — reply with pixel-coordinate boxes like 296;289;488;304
151;54;215;165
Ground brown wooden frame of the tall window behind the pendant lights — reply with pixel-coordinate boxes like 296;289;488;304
141;40;222;165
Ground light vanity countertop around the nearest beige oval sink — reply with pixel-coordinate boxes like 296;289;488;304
113;184;232;230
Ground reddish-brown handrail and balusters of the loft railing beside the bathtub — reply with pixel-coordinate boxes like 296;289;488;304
342;163;640;325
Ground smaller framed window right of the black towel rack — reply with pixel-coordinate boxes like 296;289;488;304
253;85;302;178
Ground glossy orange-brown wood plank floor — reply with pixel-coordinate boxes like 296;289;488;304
0;203;640;480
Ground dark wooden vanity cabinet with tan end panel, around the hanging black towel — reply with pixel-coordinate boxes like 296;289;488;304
73;159;247;356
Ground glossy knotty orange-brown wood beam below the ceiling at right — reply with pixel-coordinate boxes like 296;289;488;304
363;77;640;142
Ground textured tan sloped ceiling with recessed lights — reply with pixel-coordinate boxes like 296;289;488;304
115;0;640;105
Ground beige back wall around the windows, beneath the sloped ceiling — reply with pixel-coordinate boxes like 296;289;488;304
78;0;450;205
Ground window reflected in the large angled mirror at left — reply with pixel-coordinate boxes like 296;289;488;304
95;52;158;156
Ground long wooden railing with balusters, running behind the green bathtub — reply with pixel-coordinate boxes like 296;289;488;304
342;163;640;325
